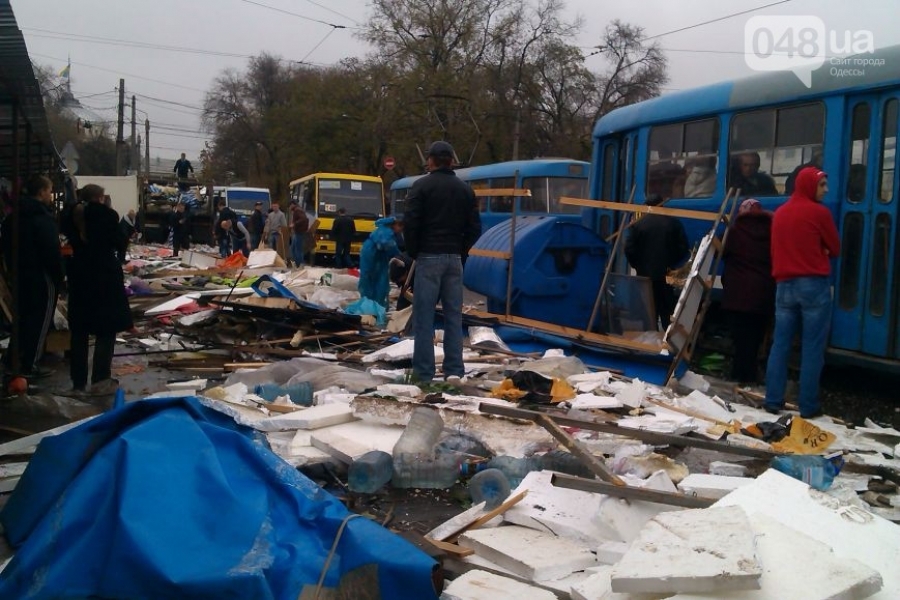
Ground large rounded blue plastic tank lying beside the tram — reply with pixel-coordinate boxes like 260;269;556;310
463;216;610;329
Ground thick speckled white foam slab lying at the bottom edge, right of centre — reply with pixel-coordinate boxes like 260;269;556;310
610;506;762;594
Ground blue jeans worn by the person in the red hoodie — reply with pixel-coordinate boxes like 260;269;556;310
766;277;831;415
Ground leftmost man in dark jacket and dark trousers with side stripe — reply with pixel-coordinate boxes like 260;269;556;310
0;175;63;378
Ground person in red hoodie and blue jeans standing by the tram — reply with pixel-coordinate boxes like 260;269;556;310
765;167;841;418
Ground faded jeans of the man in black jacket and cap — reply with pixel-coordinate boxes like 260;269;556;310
412;254;466;382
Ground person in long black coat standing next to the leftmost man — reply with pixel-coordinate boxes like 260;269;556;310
64;184;134;395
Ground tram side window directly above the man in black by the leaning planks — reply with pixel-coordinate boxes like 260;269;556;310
646;119;719;199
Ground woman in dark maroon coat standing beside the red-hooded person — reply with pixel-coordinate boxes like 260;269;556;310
722;198;775;384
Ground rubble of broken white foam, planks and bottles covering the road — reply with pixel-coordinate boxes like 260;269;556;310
0;241;900;600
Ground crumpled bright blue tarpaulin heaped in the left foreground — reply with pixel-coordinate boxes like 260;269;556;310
0;398;437;600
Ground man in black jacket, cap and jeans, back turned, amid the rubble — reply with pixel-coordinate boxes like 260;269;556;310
404;142;481;382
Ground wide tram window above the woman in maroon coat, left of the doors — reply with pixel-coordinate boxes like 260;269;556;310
728;103;825;196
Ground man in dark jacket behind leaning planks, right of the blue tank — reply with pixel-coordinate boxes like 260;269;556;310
625;195;689;331
